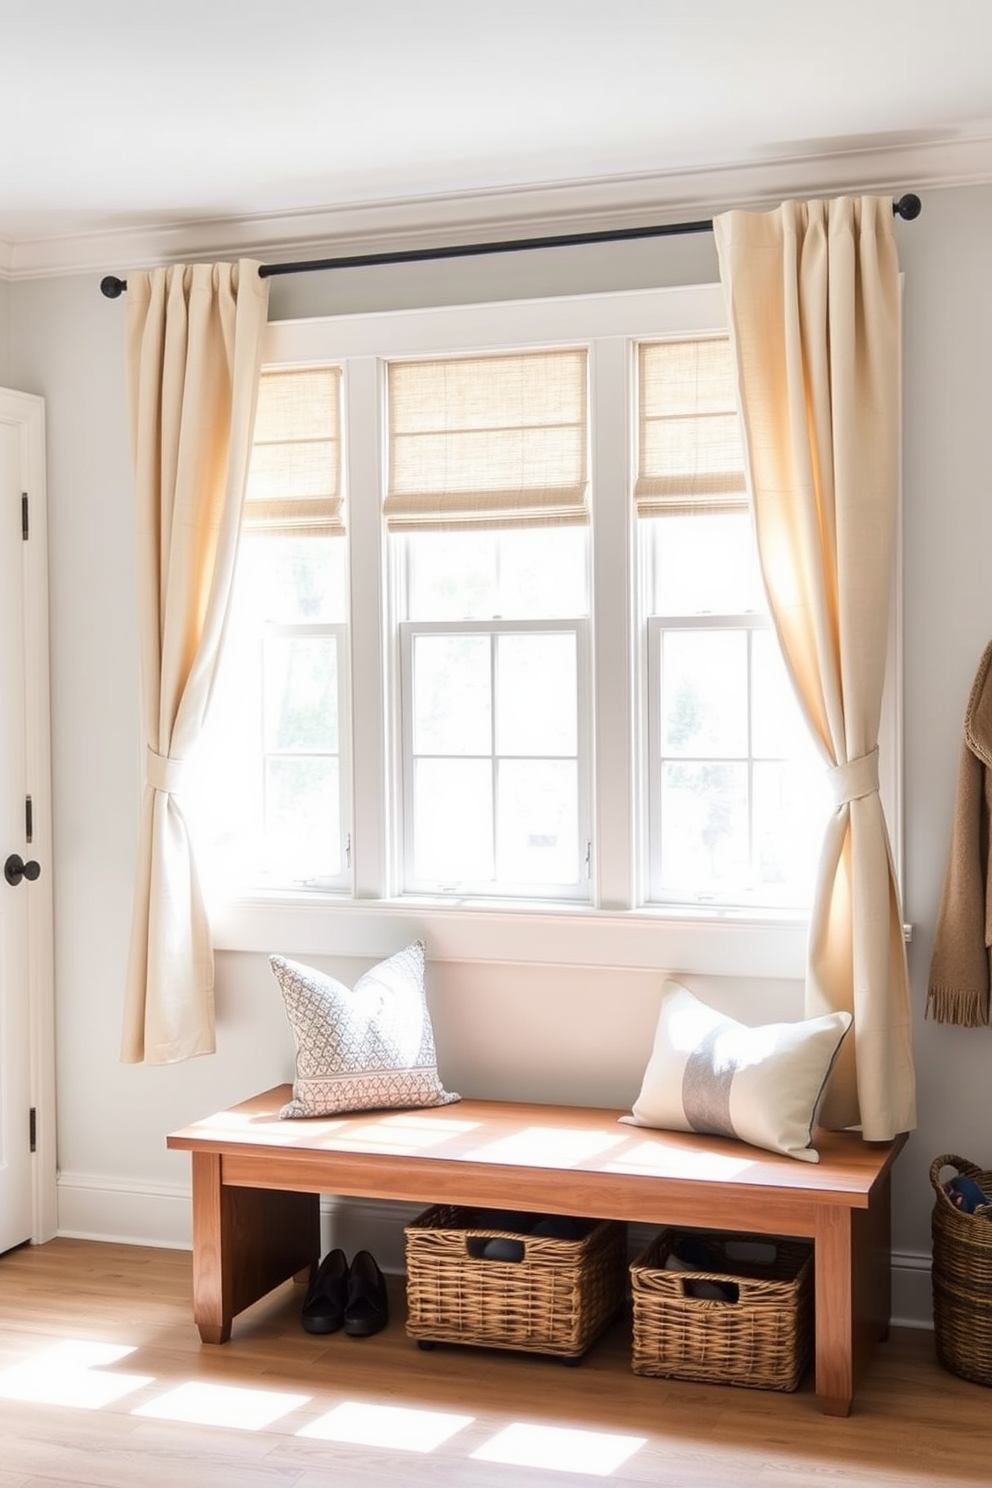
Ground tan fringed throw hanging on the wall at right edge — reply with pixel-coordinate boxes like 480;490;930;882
927;643;992;1028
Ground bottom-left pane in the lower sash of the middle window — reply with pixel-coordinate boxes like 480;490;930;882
413;759;492;885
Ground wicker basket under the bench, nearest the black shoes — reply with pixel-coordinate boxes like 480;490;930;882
406;1204;626;1359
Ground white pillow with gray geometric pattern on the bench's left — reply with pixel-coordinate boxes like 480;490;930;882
269;940;460;1116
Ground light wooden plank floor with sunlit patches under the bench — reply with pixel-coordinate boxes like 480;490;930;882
0;1240;992;1488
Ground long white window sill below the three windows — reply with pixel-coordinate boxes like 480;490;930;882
211;891;808;979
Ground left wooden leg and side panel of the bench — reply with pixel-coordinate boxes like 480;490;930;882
192;1152;320;1344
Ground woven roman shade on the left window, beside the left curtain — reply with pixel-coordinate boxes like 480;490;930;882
241;368;345;537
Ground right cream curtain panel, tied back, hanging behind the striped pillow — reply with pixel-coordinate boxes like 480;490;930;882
714;196;915;1141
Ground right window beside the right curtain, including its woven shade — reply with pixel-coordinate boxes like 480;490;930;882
634;336;830;908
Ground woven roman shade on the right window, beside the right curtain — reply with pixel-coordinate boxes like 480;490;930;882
634;336;748;516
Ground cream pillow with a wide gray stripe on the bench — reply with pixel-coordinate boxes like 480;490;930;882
620;981;852;1162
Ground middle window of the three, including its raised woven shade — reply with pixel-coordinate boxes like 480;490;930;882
384;348;589;899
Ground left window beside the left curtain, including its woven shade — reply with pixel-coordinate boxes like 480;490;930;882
190;368;351;888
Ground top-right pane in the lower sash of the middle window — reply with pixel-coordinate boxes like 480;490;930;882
497;635;577;756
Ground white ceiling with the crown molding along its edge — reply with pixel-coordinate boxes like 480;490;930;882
0;0;992;272
